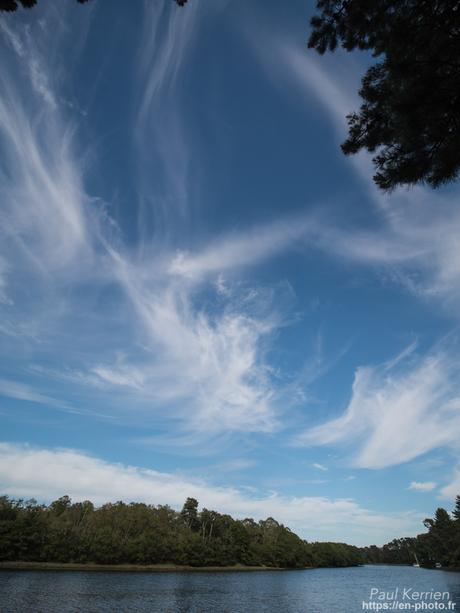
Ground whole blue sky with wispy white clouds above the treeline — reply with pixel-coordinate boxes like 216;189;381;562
0;0;460;544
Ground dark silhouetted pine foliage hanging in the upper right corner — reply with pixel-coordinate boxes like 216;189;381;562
308;0;460;190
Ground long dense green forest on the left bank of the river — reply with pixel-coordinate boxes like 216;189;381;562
0;496;363;568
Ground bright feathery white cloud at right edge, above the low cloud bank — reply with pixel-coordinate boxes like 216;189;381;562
297;340;460;468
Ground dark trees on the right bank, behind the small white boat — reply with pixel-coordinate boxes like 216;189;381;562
362;496;460;568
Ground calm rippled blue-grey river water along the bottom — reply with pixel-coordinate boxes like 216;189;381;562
0;566;460;613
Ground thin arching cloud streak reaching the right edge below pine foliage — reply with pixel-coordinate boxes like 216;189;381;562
169;206;460;312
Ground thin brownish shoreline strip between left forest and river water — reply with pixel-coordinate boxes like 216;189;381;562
0;562;314;573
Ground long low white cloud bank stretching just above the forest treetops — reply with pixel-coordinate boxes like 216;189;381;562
0;443;423;544
